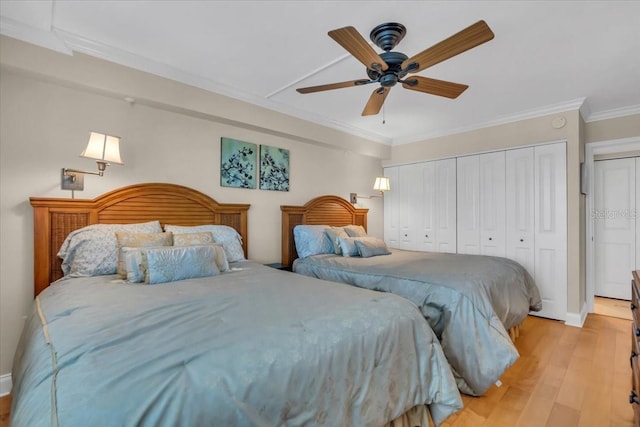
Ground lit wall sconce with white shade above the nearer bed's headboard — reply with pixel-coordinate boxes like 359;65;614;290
62;132;124;191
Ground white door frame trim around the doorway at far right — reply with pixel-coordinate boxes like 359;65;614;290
584;136;640;313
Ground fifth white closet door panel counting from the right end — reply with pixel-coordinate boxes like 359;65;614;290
435;159;457;253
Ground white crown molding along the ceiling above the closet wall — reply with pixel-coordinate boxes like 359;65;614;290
393;98;586;146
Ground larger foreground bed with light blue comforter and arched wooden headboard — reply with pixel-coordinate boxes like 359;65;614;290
11;184;462;426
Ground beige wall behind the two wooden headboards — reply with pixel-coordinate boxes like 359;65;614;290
0;37;390;382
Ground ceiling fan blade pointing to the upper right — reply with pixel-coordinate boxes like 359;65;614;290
402;21;494;73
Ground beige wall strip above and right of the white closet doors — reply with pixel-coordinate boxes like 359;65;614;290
383;110;586;315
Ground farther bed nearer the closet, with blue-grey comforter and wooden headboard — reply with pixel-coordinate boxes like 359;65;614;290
281;196;541;395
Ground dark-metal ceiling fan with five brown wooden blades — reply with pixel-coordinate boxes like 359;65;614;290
296;21;494;116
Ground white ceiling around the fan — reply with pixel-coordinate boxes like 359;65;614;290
0;0;640;144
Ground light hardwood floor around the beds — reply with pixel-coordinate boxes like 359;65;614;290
0;314;634;427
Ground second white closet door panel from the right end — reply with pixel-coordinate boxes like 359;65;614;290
505;147;535;277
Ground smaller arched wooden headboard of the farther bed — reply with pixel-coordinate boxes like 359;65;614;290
280;196;369;266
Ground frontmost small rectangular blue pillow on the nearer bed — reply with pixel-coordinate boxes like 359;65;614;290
124;245;219;285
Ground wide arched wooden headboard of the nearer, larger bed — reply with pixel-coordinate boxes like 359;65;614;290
30;183;250;295
